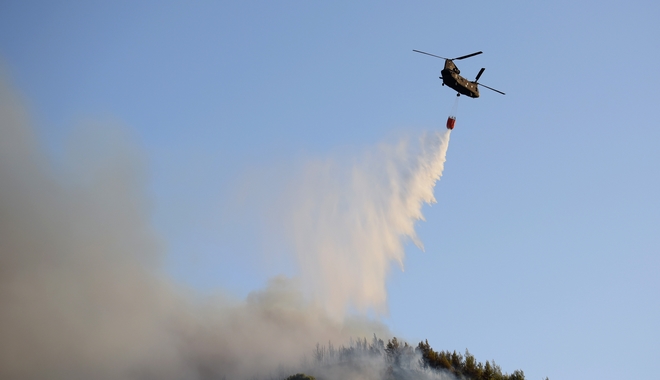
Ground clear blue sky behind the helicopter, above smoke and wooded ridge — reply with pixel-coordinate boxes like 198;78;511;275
0;0;660;379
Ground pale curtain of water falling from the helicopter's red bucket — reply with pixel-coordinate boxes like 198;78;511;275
291;130;450;318
